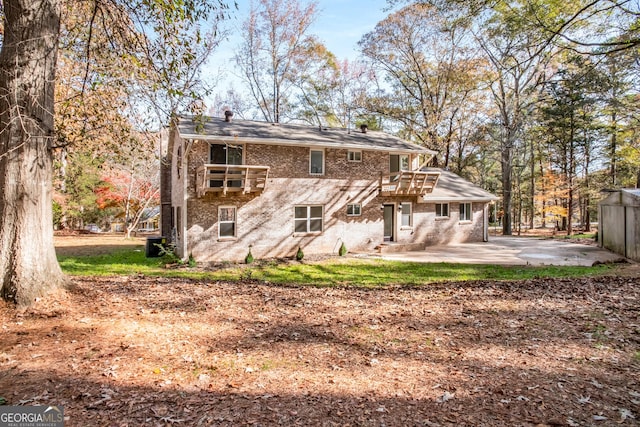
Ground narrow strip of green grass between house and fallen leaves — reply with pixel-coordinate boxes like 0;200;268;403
59;247;615;287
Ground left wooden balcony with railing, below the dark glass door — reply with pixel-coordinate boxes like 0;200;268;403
196;164;269;197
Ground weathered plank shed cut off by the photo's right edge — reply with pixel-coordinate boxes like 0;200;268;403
598;189;640;261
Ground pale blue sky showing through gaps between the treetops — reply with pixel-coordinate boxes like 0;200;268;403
205;0;388;90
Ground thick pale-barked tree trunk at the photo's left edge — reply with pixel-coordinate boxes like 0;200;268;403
0;0;64;306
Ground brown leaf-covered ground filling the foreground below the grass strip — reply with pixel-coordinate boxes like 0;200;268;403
0;236;640;427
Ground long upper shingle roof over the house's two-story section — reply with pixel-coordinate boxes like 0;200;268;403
178;117;435;154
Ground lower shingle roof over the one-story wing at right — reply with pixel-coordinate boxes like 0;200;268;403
422;168;499;202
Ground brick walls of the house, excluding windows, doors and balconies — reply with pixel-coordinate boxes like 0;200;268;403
174;141;484;261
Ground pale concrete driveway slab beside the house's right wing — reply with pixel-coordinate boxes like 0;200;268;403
380;236;625;266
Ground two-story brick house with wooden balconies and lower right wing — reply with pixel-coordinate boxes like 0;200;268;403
171;116;495;261
